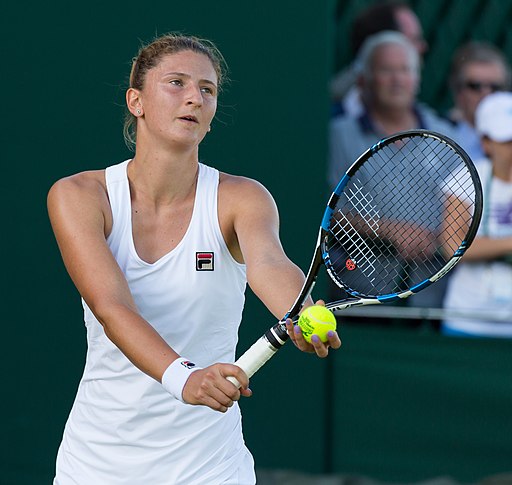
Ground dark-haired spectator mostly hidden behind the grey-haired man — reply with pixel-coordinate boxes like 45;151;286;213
330;0;428;116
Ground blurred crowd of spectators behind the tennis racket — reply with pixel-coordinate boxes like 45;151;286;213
328;0;512;337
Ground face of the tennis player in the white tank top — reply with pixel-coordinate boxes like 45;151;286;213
137;51;218;145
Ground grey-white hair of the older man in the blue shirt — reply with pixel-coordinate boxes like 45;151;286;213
356;30;420;79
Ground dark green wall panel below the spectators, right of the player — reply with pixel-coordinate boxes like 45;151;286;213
330;325;512;485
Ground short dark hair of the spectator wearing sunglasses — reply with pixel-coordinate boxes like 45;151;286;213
449;41;512;92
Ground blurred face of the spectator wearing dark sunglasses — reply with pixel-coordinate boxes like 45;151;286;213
456;62;506;123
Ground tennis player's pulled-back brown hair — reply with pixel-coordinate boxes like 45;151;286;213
123;32;227;150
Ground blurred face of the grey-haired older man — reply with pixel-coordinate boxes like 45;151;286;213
368;44;418;110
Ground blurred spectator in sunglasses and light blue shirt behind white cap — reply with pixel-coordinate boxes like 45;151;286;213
449;41;511;160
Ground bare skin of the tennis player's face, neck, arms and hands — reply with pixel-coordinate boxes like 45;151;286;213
48;51;341;412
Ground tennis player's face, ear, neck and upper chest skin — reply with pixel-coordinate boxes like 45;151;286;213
126;51;218;262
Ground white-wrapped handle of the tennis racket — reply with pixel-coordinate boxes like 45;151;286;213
227;325;288;388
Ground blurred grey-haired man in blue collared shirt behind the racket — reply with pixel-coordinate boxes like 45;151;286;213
328;31;453;308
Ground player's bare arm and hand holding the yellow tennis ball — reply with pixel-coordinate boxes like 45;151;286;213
223;177;341;357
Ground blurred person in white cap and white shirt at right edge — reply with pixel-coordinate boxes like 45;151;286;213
441;92;512;338
